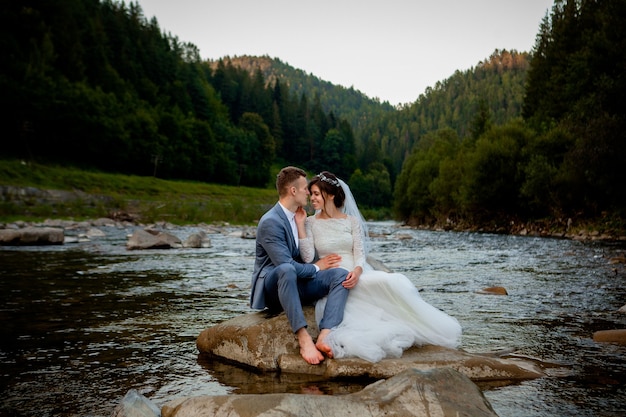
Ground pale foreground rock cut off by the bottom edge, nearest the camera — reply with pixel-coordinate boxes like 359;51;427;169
161;369;497;417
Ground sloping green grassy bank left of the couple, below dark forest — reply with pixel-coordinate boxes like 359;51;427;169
0;160;277;224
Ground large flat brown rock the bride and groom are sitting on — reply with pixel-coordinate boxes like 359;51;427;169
196;306;544;381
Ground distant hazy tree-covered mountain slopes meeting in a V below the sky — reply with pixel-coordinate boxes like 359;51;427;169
210;50;530;210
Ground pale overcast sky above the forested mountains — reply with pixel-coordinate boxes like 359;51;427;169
133;0;553;105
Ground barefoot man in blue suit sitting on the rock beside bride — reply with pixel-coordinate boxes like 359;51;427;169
250;167;349;365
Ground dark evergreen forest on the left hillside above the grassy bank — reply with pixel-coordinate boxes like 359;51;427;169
0;0;356;186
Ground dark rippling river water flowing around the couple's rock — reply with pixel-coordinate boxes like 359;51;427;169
0;222;626;417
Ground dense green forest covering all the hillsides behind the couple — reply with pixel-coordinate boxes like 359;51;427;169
0;0;626;229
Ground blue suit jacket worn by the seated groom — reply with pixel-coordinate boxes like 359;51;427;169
250;203;316;309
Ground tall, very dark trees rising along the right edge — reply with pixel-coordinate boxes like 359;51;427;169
523;0;626;215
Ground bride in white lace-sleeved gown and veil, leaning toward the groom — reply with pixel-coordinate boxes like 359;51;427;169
296;171;461;362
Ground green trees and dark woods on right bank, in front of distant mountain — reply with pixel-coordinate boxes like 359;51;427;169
394;0;626;228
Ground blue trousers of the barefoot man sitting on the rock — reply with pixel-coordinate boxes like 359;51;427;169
265;264;349;333
